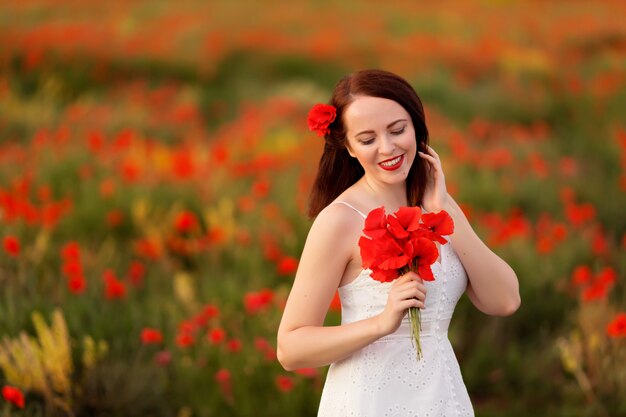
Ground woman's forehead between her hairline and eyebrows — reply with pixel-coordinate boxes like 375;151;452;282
343;96;411;134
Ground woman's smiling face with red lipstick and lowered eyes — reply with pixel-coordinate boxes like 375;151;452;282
343;96;417;184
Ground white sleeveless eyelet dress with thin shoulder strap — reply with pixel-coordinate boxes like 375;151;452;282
318;202;474;417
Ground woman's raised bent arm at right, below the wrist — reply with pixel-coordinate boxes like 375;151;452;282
443;193;521;316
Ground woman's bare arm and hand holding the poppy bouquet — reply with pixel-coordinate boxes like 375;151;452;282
277;206;425;371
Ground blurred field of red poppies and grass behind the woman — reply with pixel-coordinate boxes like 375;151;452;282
0;0;626;417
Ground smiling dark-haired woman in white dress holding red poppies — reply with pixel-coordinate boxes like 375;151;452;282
277;70;520;417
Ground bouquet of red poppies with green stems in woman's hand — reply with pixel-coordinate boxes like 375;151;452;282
359;207;454;360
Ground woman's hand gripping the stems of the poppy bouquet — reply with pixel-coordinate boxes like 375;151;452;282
377;272;426;337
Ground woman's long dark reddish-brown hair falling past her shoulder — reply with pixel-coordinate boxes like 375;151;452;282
308;69;428;218
